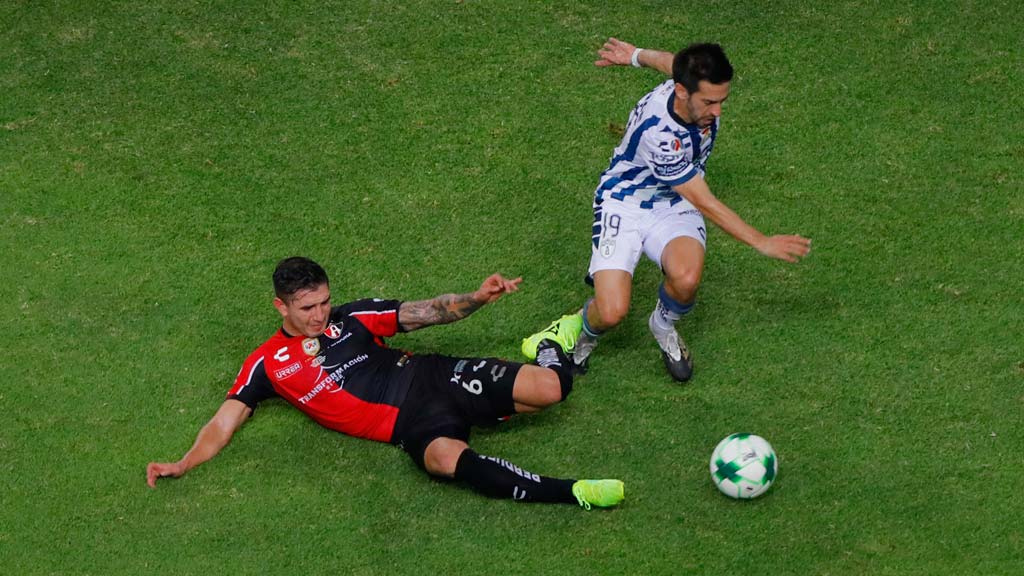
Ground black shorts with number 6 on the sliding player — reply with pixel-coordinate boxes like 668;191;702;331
391;356;522;468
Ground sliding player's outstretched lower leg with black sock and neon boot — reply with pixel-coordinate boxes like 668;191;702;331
423;437;624;509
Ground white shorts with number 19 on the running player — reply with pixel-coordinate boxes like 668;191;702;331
589;199;708;276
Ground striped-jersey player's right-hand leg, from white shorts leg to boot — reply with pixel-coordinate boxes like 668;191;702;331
645;212;705;381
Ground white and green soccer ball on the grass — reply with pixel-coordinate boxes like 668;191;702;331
711;434;778;499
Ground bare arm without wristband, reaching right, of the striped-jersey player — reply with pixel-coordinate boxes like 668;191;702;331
673;176;811;262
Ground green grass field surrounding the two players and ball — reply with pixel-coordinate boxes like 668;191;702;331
0;0;1024;575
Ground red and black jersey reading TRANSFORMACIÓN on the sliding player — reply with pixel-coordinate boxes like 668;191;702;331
227;299;413;442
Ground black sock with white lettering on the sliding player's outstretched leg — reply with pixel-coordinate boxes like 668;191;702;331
455;448;577;503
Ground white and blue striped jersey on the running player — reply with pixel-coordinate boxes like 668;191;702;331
594;80;719;209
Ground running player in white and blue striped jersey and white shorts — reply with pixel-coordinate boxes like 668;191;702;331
523;38;811;381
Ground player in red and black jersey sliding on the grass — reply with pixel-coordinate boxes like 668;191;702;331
146;257;623;509
